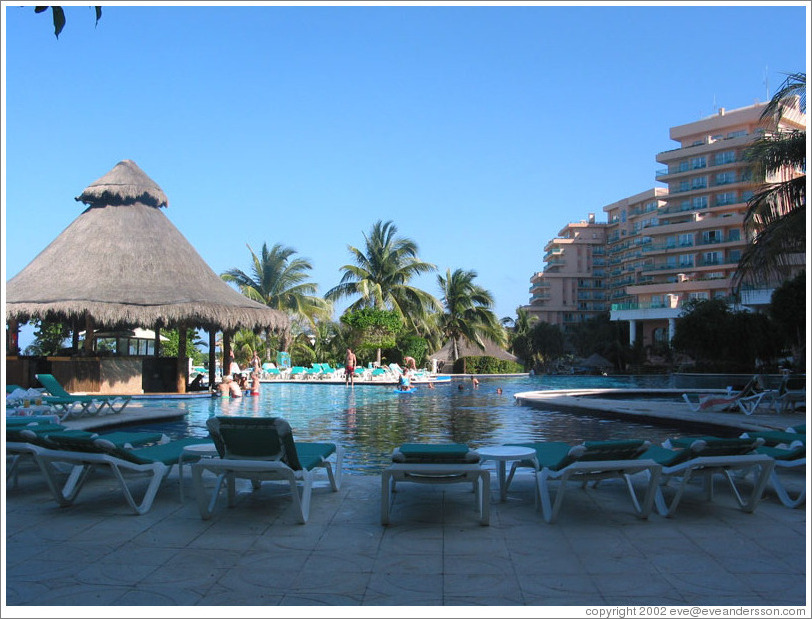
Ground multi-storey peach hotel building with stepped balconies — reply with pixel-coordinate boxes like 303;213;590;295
525;103;806;354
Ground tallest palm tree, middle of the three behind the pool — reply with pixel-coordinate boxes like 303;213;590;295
324;220;440;331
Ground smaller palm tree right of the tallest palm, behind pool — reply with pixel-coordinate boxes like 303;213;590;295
437;269;505;361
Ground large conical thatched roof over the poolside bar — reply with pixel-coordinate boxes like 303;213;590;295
6;160;288;330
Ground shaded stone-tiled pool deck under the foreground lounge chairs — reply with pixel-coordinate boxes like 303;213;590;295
2;393;810;617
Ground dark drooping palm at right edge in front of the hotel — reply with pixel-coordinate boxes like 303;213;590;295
733;73;806;288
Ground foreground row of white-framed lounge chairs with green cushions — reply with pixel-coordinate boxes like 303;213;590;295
7;416;806;525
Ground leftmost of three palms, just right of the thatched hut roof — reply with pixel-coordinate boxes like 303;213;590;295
220;243;331;360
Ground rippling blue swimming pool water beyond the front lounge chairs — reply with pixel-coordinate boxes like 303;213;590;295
130;376;682;474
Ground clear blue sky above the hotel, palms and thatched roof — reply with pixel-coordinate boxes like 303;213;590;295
2;2;809;345
